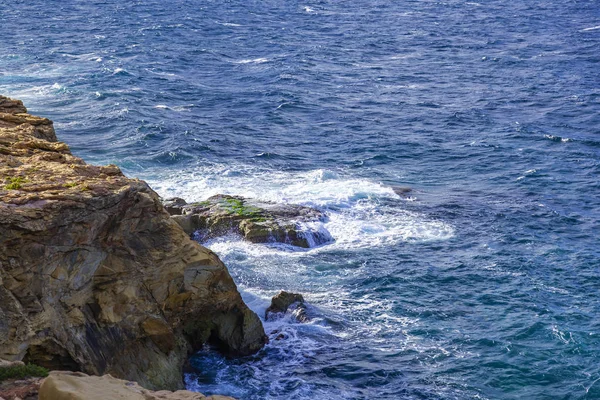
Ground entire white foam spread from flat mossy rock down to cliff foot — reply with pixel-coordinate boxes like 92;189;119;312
157;164;452;399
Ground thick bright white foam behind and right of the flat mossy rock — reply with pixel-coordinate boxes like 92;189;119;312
149;165;454;250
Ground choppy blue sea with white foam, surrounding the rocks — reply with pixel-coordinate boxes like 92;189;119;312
0;0;600;400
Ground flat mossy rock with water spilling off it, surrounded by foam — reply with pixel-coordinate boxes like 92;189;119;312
164;195;333;248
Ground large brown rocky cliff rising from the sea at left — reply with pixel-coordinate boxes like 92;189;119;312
0;97;266;389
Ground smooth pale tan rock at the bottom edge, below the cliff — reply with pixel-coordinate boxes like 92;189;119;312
39;371;234;400
